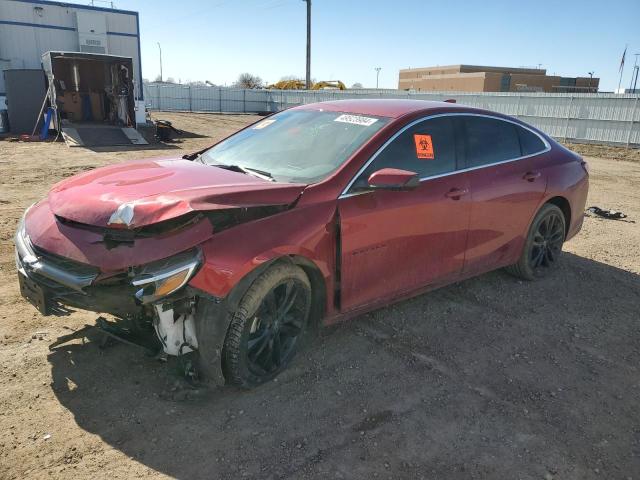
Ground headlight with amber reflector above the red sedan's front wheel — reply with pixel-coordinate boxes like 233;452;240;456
131;250;202;303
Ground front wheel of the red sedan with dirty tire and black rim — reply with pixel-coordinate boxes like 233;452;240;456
222;263;311;388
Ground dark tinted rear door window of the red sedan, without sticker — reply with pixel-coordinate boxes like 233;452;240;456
464;116;522;167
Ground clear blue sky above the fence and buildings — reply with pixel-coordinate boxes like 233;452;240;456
82;0;640;90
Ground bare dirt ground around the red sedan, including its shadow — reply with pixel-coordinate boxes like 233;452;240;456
0;114;640;480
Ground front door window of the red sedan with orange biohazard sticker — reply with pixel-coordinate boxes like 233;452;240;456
352;116;456;190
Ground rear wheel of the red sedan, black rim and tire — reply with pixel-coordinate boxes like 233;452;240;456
505;203;566;280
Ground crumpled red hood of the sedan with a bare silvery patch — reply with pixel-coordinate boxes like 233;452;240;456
48;159;305;228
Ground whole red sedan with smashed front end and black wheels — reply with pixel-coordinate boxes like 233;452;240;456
16;100;588;387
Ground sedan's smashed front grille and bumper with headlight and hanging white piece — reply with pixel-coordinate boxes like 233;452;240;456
15;216;202;346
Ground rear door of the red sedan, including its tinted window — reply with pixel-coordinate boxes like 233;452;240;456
456;115;547;275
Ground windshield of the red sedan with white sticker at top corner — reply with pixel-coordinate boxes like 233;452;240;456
200;110;387;184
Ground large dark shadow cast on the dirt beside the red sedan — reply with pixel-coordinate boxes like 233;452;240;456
49;254;640;479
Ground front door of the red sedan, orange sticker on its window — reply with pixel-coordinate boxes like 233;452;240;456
338;116;469;310
